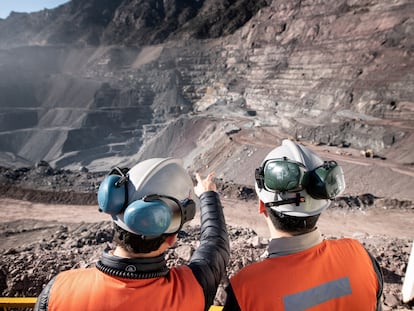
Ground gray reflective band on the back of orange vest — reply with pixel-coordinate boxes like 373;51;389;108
283;277;352;311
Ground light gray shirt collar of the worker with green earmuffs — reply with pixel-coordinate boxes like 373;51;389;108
268;229;323;258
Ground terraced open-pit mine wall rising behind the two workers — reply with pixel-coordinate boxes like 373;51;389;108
0;0;414;177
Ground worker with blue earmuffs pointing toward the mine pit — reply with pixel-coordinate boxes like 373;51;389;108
35;158;229;311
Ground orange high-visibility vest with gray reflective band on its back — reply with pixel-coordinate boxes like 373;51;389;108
230;239;379;311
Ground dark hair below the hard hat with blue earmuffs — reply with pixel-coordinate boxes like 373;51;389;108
113;223;168;254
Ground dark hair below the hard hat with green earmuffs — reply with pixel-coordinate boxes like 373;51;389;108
266;206;320;235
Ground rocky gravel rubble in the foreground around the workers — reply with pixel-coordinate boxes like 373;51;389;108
0;220;414;310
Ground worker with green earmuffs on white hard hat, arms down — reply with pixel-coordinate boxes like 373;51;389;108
223;140;383;311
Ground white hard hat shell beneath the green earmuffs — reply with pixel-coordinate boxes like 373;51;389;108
255;139;345;217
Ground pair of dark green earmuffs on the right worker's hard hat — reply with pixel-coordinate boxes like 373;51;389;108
255;158;345;199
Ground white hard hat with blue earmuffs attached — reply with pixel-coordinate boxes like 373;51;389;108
98;158;196;236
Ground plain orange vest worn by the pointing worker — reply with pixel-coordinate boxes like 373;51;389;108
48;266;204;311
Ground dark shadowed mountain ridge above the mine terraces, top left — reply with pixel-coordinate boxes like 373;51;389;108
0;0;268;47
